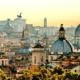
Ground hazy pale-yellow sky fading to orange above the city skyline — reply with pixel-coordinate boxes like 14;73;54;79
0;0;80;26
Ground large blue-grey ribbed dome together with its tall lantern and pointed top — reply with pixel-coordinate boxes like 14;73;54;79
51;24;73;54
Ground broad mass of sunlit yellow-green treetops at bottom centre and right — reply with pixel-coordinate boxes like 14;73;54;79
19;66;80;80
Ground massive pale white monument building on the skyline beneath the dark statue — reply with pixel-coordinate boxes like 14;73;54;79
0;13;26;32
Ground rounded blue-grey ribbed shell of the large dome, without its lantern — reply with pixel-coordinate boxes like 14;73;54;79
51;39;73;54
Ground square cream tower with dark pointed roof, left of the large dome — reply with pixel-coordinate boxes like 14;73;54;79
32;43;46;66
